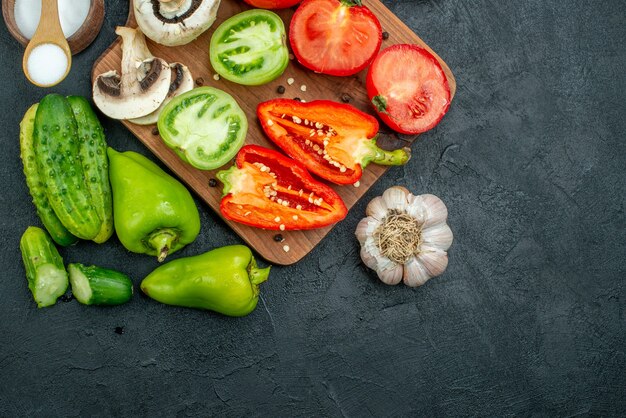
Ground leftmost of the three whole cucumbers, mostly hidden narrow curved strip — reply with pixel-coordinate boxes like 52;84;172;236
20;103;78;246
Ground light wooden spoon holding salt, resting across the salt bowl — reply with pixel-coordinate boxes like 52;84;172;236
22;0;72;87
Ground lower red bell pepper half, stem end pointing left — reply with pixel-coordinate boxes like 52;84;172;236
217;145;348;230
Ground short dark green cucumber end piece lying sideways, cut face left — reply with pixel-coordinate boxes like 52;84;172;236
67;263;133;305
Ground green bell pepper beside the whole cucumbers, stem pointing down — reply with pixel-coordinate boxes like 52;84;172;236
107;148;200;261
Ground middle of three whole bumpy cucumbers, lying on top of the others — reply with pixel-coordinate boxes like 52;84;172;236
34;94;102;240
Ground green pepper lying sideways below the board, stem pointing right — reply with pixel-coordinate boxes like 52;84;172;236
141;245;271;316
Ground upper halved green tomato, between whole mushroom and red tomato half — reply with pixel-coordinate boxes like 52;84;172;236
209;9;289;86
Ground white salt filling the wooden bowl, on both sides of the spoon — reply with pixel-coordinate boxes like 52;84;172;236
13;0;91;39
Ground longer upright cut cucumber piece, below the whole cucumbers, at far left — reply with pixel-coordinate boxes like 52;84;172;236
20;226;69;308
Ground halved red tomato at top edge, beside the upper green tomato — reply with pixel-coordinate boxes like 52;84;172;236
289;0;382;76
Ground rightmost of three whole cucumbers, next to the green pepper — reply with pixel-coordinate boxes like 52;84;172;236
67;96;113;244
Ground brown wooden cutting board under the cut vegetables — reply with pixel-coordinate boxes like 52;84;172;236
92;0;456;265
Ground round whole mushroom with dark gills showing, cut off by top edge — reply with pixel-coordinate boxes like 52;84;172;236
133;0;220;46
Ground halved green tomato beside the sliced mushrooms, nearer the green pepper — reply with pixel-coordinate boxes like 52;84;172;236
158;87;248;170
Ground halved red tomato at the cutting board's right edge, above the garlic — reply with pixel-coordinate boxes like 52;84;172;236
367;44;450;134
